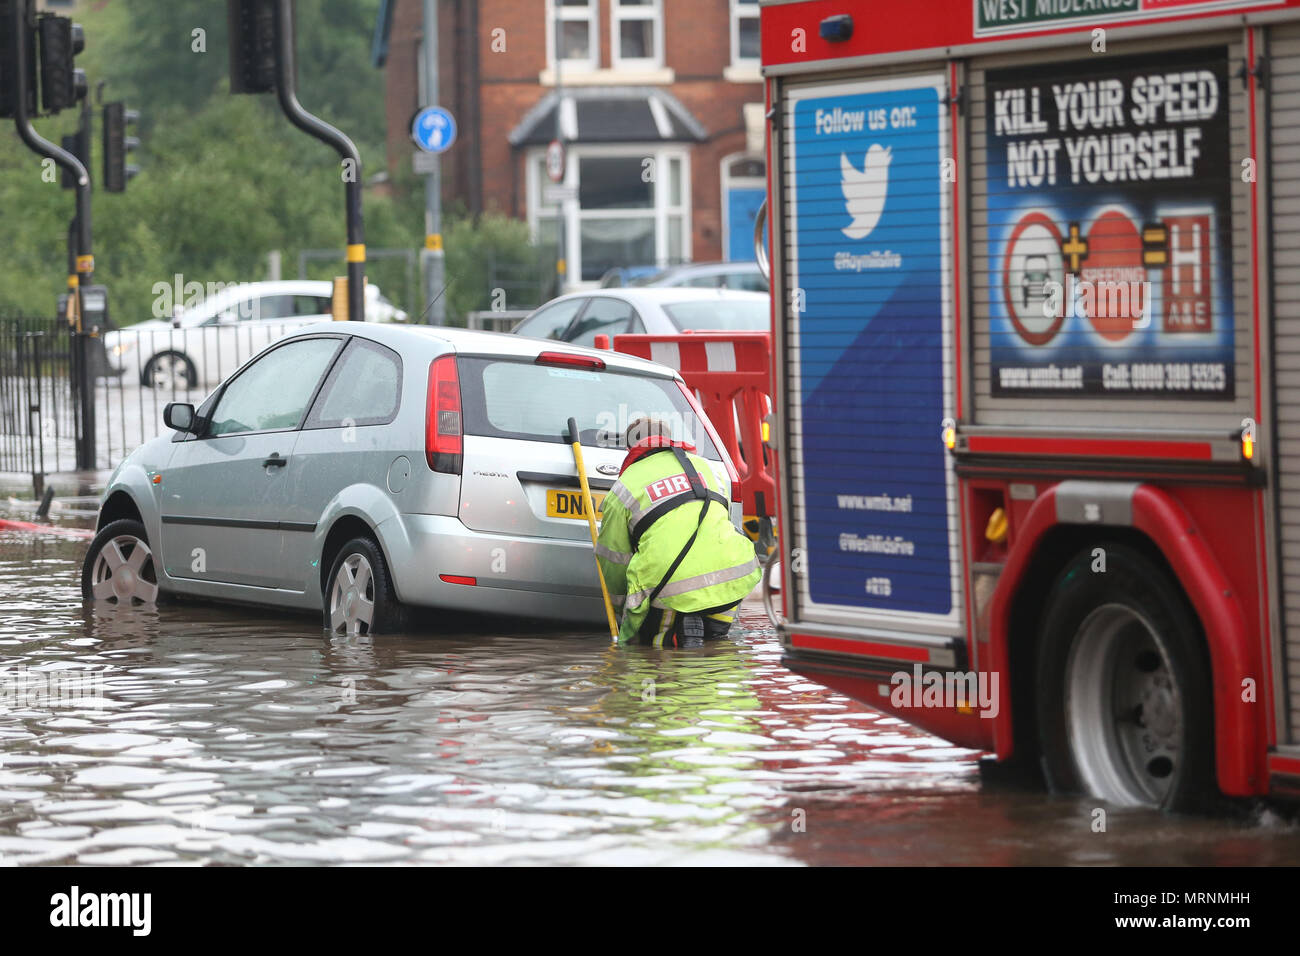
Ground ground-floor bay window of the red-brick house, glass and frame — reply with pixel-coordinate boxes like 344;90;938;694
528;146;690;285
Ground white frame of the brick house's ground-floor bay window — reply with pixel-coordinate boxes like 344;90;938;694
524;143;692;291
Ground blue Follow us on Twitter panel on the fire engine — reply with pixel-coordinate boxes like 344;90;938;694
792;74;954;615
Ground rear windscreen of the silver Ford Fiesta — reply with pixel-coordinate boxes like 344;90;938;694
456;356;722;462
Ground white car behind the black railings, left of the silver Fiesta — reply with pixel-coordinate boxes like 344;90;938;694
104;280;407;392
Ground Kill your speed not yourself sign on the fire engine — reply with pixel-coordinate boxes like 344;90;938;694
985;48;1234;401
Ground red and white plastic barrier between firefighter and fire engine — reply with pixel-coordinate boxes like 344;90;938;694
602;332;776;535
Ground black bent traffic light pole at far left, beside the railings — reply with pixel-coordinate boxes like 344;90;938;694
7;4;95;471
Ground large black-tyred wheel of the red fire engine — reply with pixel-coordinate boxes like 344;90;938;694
1037;542;1216;810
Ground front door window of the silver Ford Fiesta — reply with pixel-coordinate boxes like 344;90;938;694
205;338;339;437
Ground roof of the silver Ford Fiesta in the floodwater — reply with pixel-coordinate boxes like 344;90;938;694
293;323;681;378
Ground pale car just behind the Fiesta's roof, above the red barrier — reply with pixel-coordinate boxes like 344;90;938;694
514;287;771;346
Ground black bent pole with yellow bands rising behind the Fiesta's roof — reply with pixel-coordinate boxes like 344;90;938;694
267;0;365;321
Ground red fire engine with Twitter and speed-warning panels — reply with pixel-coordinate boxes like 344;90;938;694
759;0;1300;810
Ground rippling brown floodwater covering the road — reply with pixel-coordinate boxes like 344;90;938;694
0;532;1300;865
